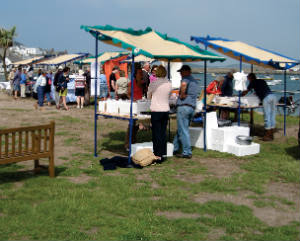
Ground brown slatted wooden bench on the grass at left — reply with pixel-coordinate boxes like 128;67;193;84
0;121;55;177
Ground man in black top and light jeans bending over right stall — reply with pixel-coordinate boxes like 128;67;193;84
242;73;277;141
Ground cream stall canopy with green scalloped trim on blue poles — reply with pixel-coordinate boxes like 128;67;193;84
81;25;225;164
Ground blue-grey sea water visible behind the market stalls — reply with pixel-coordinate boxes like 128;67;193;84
0;73;300;116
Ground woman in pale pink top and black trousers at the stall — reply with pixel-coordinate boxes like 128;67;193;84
147;65;172;162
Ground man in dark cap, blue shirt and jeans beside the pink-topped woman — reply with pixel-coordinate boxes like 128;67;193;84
173;65;199;159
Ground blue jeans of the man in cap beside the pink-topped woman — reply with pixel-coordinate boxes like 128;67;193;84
173;106;194;155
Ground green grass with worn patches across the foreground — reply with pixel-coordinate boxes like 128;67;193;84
0;114;300;240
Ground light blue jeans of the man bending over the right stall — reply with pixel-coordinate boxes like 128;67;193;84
263;94;277;130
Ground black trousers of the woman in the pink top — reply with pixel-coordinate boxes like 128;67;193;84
151;112;169;157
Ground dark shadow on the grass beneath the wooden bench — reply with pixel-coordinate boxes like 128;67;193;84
0;167;67;184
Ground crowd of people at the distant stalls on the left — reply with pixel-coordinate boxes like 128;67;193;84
8;66;91;110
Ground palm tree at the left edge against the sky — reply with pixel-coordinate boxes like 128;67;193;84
0;26;16;81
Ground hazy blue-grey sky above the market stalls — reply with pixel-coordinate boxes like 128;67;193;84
0;0;300;64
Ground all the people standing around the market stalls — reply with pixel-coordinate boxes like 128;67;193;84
9;62;276;164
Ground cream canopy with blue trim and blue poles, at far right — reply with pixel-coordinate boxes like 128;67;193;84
191;36;299;135
